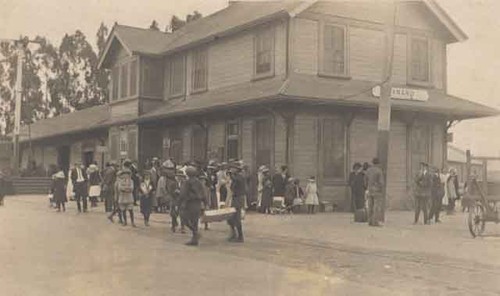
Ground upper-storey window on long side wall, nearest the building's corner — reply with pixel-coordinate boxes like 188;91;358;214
254;29;274;77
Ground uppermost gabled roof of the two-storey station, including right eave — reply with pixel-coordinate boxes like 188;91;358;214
99;0;467;67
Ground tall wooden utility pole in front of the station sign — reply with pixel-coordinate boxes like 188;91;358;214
377;0;398;222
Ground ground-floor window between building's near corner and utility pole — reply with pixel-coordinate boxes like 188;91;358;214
321;118;346;180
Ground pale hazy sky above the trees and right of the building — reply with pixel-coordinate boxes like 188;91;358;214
0;0;500;156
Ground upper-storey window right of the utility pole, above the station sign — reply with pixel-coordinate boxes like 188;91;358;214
409;37;431;84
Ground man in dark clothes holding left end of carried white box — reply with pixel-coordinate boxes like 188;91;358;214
179;165;205;246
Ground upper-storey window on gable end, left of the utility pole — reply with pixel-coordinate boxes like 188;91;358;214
319;24;348;76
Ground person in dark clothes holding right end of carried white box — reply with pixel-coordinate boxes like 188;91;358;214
227;162;246;243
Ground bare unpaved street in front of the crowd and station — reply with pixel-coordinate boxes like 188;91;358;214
0;197;500;296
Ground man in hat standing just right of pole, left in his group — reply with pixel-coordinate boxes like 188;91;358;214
414;162;432;224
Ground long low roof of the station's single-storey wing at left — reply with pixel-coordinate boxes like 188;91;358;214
19;105;109;142
